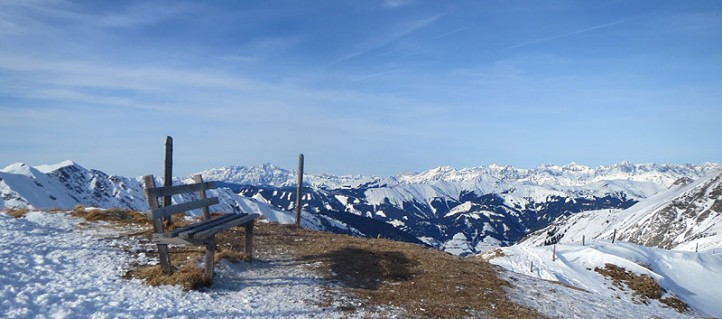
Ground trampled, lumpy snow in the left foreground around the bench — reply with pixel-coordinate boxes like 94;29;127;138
0;212;370;318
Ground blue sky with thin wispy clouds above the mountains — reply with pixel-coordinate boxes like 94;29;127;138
0;0;722;176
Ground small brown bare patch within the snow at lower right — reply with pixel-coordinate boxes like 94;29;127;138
594;264;689;313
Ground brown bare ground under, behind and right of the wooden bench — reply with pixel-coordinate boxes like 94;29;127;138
91;213;543;318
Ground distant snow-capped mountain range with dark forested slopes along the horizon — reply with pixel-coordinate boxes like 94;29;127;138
0;161;722;254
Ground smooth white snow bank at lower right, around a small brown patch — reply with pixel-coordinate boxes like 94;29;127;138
483;242;722;318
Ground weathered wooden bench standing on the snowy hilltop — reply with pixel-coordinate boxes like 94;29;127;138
143;175;260;280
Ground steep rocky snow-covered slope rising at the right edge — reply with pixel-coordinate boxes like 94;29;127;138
522;171;722;251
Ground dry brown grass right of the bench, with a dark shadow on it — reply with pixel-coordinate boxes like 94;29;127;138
233;224;542;318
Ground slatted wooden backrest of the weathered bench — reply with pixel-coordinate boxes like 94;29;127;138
143;175;218;233
